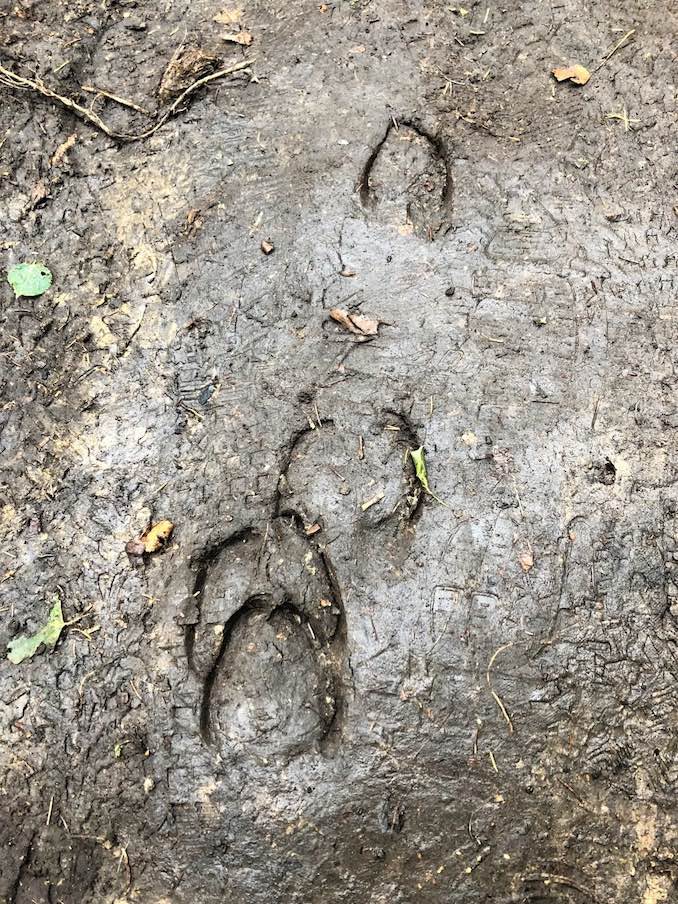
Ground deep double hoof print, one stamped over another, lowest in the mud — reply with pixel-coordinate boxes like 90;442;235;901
185;515;346;756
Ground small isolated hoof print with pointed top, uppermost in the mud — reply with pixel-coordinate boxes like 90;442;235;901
358;120;452;240
